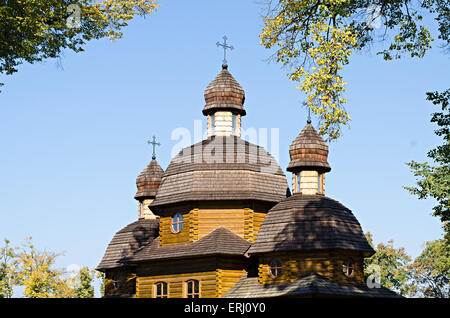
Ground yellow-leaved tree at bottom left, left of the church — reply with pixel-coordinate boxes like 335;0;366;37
17;237;75;298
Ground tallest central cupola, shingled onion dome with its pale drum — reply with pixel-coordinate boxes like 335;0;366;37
203;64;245;137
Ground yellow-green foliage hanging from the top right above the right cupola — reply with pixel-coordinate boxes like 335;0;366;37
260;0;450;140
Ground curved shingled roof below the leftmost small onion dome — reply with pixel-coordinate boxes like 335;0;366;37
96;219;159;271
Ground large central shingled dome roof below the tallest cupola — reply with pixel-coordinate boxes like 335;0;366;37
150;136;288;212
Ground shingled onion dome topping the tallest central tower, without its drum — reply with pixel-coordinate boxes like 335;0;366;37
203;65;245;116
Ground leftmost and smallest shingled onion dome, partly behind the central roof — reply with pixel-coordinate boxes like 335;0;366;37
134;159;164;200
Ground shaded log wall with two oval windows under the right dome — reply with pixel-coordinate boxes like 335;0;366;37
258;252;364;284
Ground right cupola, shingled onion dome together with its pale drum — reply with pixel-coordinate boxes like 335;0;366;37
287;120;331;195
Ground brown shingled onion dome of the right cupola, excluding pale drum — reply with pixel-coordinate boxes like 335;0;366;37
287;120;331;172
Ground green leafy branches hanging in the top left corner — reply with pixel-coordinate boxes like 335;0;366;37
0;0;159;89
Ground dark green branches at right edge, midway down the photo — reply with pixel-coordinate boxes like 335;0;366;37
405;89;450;242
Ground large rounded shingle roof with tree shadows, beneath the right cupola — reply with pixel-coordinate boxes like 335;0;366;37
249;194;374;256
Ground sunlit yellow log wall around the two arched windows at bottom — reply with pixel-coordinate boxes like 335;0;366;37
136;269;246;298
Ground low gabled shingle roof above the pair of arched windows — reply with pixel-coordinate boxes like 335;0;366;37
131;226;250;262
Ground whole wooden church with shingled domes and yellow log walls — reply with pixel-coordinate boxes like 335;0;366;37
97;57;397;298
